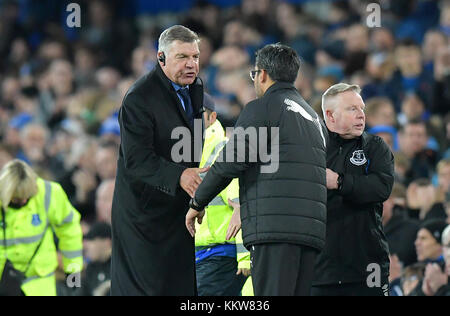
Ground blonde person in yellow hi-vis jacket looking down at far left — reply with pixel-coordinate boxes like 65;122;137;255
0;159;83;296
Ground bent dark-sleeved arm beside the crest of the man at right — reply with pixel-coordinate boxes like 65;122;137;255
340;137;394;204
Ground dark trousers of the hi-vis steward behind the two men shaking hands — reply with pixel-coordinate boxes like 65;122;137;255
195;256;247;296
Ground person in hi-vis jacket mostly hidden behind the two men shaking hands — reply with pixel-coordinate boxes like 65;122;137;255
195;93;250;296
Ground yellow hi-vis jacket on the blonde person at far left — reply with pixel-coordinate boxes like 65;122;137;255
0;178;83;296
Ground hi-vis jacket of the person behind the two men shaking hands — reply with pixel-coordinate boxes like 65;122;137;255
195;120;250;269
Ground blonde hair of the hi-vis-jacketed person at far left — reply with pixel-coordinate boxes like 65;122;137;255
0;159;38;209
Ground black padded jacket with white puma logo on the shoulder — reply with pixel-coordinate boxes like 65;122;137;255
195;82;327;250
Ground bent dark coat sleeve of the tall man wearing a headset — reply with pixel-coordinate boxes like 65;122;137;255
119;94;186;196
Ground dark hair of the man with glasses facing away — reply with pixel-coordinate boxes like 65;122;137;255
256;43;300;83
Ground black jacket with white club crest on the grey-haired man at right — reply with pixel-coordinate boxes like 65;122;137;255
313;132;394;285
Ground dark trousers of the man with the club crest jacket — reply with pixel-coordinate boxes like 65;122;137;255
311;280;389;296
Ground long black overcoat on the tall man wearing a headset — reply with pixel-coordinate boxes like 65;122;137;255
111;65;203;295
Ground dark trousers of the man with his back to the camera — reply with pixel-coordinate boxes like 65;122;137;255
250;243;317;296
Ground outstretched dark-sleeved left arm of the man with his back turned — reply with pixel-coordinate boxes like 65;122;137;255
195;100;266;207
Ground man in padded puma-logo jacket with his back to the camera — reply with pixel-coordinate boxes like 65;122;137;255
186;44;326;296
